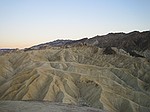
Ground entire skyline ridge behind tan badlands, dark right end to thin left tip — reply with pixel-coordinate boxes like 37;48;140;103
30;31;150;51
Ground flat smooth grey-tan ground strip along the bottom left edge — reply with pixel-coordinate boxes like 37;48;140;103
0;101;105;112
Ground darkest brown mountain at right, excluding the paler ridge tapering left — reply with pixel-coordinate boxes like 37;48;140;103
88;31;150;51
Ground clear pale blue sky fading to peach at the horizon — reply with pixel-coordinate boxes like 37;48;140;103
0;0;150;48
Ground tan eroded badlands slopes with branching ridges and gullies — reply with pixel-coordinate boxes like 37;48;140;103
0;46;150;112
